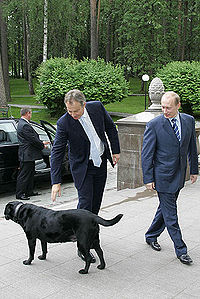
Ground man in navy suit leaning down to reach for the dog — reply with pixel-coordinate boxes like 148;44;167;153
51;89;120;214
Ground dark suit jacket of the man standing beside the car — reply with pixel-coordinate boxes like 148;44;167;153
17;118;44;162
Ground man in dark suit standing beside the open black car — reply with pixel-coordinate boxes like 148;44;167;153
16;108;49;200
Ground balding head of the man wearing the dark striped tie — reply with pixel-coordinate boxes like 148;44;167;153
161;91;181;118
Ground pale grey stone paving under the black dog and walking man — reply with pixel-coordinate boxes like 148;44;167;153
0;165;200;299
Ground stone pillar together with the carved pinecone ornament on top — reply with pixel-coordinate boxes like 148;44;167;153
117;78;164;190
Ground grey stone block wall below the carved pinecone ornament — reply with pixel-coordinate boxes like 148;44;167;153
117;111;200;190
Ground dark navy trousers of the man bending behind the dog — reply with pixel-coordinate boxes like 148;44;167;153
77;153;107;214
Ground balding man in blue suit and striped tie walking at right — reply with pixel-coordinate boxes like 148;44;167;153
142;91;198;265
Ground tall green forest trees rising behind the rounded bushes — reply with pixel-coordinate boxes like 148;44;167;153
0;0;200;114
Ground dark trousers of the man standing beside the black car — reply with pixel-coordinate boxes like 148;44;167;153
16;161;35;197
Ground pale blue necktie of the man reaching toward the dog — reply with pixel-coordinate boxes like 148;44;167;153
81;118;102;167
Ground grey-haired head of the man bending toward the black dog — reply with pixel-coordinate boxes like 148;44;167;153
64;89;86;119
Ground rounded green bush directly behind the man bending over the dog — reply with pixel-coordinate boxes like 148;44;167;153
36;58;128;115
